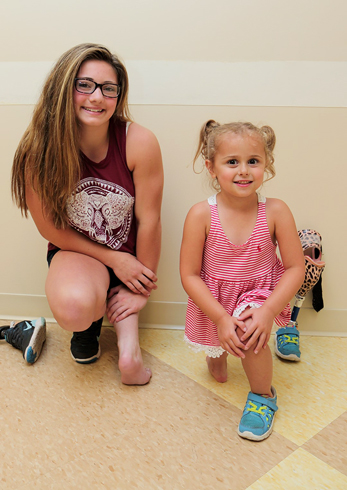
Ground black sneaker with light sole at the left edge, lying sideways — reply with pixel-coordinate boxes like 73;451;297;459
0;317;46;364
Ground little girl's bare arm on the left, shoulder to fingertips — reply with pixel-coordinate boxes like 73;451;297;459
180;201;245;358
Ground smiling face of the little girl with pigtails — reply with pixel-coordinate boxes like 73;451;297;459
206;132;266;197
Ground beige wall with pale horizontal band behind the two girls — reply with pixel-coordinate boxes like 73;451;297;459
0;0;347;333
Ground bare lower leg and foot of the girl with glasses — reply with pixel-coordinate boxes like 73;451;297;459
114;313;152;385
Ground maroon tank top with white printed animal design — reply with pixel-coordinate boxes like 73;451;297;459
48;121;136;255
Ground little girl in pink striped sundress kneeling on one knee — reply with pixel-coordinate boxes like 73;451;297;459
181;120;304;441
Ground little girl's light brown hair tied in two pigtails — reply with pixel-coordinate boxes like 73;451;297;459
193;119;276;190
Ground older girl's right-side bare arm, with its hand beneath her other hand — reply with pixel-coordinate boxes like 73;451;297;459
107;123;163;323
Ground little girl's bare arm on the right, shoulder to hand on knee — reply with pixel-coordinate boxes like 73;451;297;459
240;199;305;353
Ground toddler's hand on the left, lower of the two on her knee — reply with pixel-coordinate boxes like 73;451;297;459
217;314;246;359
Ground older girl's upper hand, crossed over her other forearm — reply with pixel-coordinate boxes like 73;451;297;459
107;252;158;297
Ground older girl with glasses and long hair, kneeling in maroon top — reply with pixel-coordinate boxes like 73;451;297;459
12;44;163;385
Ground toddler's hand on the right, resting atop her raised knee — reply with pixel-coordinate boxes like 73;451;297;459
239;305;274;354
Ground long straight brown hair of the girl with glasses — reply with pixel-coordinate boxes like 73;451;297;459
11;44;131;228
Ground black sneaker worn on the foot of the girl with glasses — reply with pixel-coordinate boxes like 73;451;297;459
70;318;103;364
